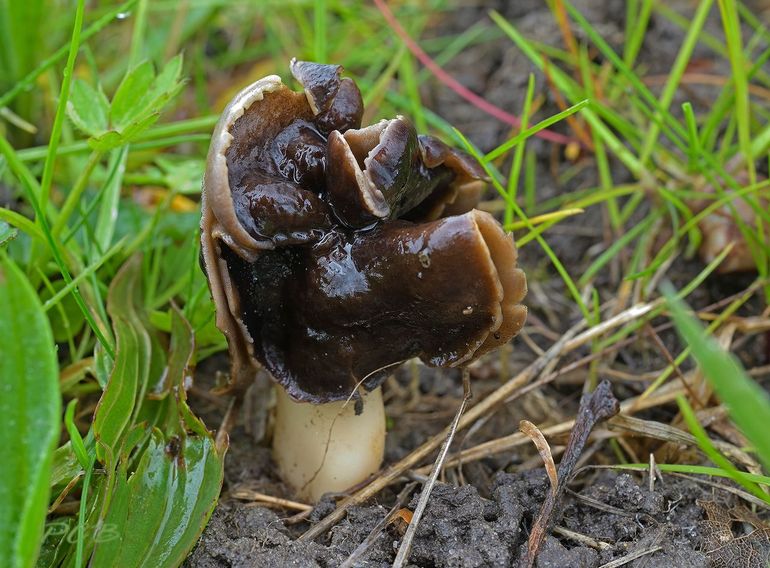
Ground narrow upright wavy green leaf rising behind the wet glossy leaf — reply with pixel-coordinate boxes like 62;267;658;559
93;256;151;464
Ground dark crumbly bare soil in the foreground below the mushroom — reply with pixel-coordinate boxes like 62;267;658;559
188;471;707;568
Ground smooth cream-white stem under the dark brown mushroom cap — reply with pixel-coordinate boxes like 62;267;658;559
273;387;385;502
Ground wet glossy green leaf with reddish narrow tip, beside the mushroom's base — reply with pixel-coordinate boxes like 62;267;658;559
90;308;226;568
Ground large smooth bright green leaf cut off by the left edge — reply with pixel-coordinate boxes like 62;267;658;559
0;253;61;567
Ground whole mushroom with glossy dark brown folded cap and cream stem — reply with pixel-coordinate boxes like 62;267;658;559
201;60;526;500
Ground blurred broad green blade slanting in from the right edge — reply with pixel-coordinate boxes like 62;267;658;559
667;293;770;471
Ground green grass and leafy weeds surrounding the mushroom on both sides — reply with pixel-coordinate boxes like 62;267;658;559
0;0;770;566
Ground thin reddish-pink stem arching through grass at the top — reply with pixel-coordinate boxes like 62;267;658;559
374;0;573;145
